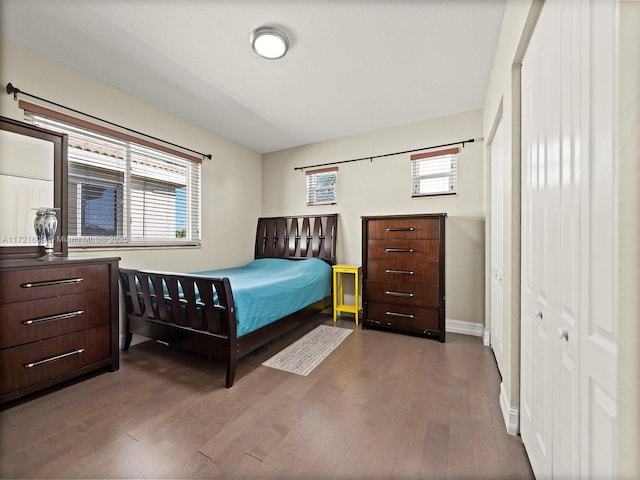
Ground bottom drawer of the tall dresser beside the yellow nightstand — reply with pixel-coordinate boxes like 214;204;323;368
365;302;440;333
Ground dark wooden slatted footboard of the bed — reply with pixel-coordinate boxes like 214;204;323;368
120;269;239;388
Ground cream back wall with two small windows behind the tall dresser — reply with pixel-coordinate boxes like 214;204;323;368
262;110;484;323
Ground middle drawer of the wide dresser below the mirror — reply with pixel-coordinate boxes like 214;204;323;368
0;290;111;348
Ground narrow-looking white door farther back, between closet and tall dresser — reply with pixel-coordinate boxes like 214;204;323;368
490;118;505;375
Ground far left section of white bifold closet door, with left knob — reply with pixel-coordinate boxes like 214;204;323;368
520;4;557;472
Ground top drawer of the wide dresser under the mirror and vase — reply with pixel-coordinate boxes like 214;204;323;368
0;264;109;303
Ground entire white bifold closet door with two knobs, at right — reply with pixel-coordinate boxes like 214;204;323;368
520;0;616;479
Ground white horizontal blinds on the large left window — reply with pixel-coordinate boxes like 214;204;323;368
25;110;201;248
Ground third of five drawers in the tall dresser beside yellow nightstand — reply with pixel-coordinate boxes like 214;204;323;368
367;260;440;285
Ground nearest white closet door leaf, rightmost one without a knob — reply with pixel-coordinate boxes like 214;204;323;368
580;1;616;479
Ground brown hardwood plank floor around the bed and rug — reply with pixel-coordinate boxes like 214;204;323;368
0;315;533;479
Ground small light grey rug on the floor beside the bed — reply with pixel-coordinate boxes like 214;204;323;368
263;325;353;376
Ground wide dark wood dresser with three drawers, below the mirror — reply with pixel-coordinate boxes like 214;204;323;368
0;257;119;403
